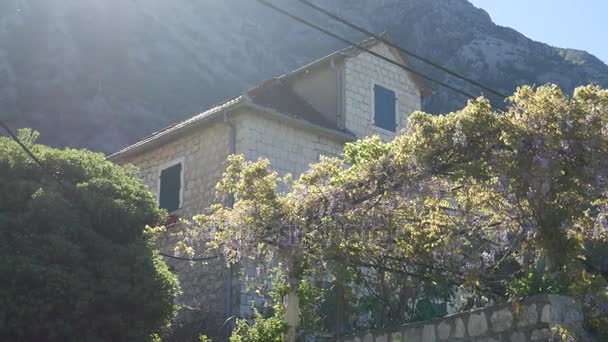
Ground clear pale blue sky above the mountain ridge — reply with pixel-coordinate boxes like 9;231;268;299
469;0;608;64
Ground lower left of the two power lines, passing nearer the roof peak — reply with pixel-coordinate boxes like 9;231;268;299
257;0;484;99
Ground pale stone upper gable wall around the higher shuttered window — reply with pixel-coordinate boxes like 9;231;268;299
343;44;421;141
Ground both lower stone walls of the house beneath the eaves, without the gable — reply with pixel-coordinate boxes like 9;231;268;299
115;111;352;336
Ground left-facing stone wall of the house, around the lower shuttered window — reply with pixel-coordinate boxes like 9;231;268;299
117;122;234;335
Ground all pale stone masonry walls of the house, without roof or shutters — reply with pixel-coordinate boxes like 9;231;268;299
115;40;420;334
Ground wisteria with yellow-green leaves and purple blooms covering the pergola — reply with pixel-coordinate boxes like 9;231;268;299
183;86;608;332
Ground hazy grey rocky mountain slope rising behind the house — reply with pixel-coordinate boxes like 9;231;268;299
0;0;608;152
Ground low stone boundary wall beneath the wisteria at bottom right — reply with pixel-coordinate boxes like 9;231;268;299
339;295;583;342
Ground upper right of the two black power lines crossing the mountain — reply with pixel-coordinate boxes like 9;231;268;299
299;0;507;99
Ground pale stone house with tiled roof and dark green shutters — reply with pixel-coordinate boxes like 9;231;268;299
109;38;429;331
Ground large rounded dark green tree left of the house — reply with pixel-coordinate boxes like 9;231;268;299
0;130;178;341
